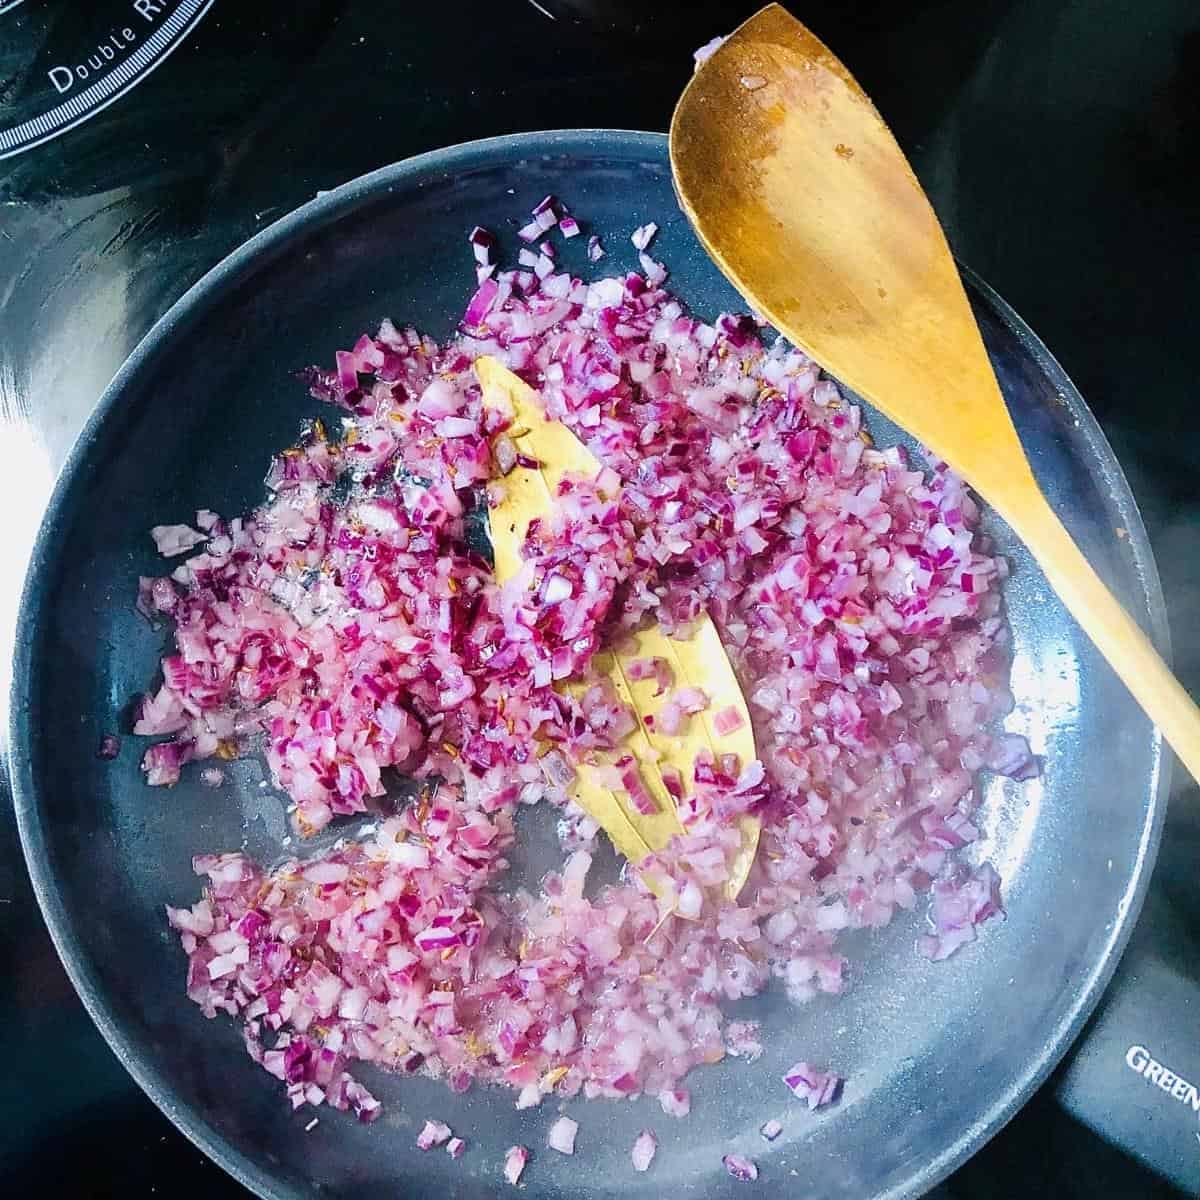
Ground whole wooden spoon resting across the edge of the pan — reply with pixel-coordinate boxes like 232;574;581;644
671;5;1200;780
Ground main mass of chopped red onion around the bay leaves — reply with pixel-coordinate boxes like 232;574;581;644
150;198;1036;1132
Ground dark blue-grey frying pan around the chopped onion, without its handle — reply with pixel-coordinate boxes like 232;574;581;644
11;131;1166;1200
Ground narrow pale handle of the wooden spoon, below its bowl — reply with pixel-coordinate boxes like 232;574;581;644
1004;486;1200;781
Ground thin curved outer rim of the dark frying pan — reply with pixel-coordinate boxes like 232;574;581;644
8;128;1170;1200
